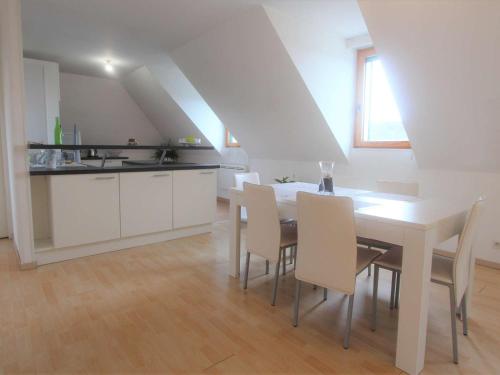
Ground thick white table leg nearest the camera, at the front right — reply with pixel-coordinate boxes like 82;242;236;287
396;229;435;375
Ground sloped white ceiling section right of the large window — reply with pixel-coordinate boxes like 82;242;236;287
359;0;500;172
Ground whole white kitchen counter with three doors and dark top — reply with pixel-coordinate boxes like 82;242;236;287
31;164;219;264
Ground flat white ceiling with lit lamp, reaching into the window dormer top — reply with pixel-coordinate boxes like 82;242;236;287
21;0;366;77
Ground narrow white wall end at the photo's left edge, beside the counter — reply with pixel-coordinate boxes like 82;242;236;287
0;0;33;265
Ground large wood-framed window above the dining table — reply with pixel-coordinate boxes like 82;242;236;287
354;48;410;148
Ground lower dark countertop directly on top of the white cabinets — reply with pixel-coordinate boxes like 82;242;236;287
30;163;220;176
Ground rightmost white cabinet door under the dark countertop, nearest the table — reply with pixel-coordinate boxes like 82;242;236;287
173;169;217;229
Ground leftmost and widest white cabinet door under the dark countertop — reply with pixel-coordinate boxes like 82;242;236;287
49;173;120;248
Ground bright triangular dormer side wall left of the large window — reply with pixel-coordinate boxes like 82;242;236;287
264;2;358;159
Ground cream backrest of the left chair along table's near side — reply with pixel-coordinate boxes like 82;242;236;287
243;182;281;262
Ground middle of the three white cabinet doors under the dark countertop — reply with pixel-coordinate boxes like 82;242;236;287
120;171;173;237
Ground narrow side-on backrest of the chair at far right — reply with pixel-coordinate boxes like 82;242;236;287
453;198;484;304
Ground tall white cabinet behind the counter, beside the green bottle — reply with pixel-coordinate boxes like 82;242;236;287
24;59;61;144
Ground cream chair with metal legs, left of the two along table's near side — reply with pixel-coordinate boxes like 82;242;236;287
243;182;297;306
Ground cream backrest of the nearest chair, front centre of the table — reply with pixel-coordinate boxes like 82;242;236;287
295;192;357;295
